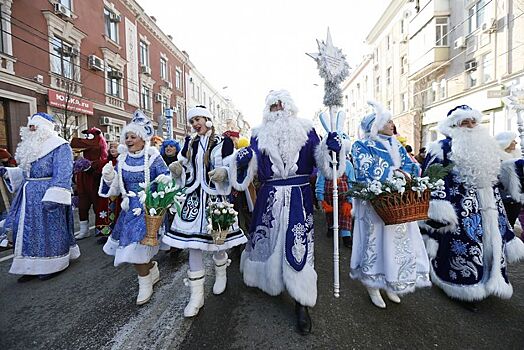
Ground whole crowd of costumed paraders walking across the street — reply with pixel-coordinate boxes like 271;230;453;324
0;90;524;335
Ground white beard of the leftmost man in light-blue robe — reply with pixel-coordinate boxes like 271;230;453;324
15;127;56;171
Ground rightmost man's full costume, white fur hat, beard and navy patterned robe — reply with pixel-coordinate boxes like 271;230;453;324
421;105;524;302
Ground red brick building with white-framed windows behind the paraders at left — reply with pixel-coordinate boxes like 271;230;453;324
0;0;211;151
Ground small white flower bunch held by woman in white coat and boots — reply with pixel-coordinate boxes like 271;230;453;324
206;201;238;245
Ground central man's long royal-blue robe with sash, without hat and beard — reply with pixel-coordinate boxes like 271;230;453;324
231;123;345;306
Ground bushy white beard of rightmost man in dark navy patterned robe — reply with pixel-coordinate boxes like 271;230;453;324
450;126;502;188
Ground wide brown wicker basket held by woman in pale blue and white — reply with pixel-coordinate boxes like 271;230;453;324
371;190;430;225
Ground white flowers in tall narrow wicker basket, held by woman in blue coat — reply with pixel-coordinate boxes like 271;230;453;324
139;174;185;246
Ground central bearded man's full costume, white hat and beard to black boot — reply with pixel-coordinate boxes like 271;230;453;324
231;90;345;333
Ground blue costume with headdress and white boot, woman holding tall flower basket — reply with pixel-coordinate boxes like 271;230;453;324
98;111;169;305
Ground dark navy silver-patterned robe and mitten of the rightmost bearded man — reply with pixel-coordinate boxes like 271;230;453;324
421;138;524;301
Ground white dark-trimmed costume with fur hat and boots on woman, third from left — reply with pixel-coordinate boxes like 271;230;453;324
163;106;246;317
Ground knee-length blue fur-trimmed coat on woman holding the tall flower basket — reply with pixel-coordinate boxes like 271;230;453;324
99;147;170;266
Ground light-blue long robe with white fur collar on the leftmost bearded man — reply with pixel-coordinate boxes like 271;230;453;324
5;141;80;275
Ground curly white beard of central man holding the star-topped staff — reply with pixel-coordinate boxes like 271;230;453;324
257;110;308;164
